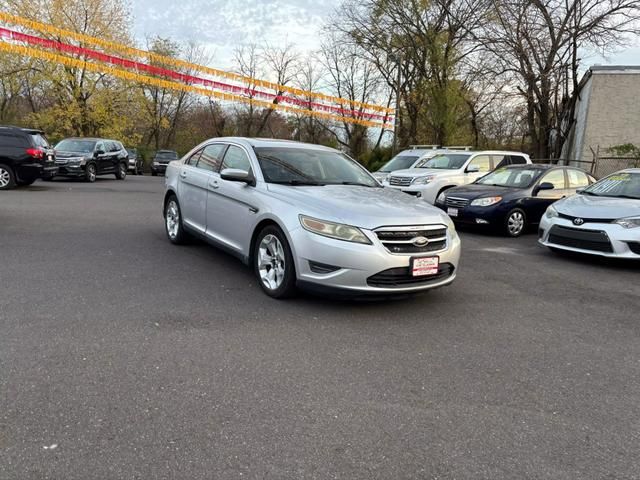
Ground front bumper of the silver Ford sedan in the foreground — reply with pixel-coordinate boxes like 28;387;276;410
289;224;460;295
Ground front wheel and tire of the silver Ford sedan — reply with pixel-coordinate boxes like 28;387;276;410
253;225;296;299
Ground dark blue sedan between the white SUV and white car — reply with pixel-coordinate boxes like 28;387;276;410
436;165;595;237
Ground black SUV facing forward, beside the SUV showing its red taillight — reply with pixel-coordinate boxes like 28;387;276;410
56;138;129;182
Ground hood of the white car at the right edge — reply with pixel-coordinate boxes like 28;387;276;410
554;195;640;220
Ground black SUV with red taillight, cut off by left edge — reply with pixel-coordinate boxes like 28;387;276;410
0;126;57;190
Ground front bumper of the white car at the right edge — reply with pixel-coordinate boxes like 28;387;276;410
538;216;640;260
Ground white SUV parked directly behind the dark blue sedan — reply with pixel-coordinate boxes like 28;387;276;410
383;151;531;204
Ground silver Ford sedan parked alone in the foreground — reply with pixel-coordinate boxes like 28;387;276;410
163;138;460;298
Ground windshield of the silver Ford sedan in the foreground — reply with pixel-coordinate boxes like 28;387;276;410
255;147;380;187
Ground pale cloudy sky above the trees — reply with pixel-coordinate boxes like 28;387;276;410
131;0;640;69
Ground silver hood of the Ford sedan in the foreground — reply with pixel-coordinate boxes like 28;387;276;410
267;184;450;229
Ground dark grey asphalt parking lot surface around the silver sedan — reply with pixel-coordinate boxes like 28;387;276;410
0;177;640;479
